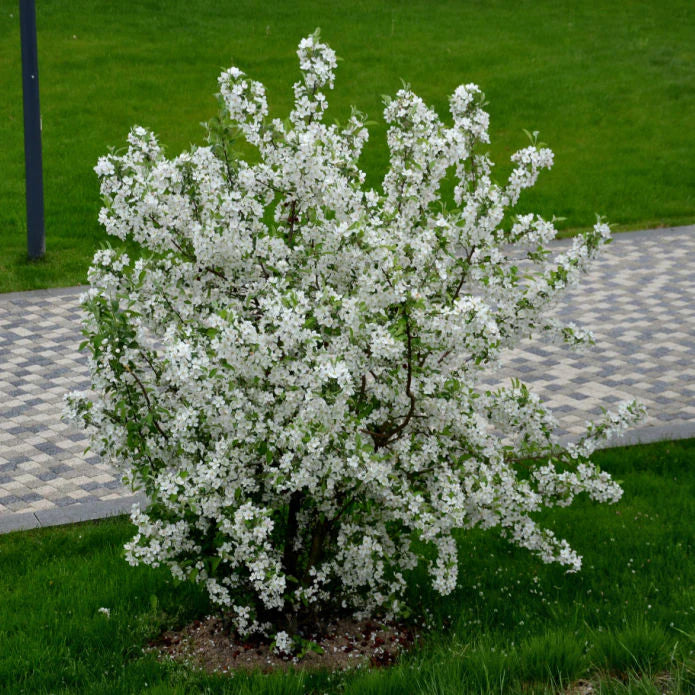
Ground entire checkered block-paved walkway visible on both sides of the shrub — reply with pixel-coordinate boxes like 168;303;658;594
0;226;695;532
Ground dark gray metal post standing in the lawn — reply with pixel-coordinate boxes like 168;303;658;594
19;0;46;258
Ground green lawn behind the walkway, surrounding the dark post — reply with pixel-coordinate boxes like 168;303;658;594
0;0;695;291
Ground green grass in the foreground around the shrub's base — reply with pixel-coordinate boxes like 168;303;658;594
0;440;695;695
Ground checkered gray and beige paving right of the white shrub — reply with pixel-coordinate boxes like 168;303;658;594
495;231;695;439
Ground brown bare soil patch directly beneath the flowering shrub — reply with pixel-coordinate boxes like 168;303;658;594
146;616;419;673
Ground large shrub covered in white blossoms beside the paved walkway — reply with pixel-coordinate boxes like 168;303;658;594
67;34;642;640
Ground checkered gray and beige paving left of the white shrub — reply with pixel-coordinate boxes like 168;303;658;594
0;288;132;515
